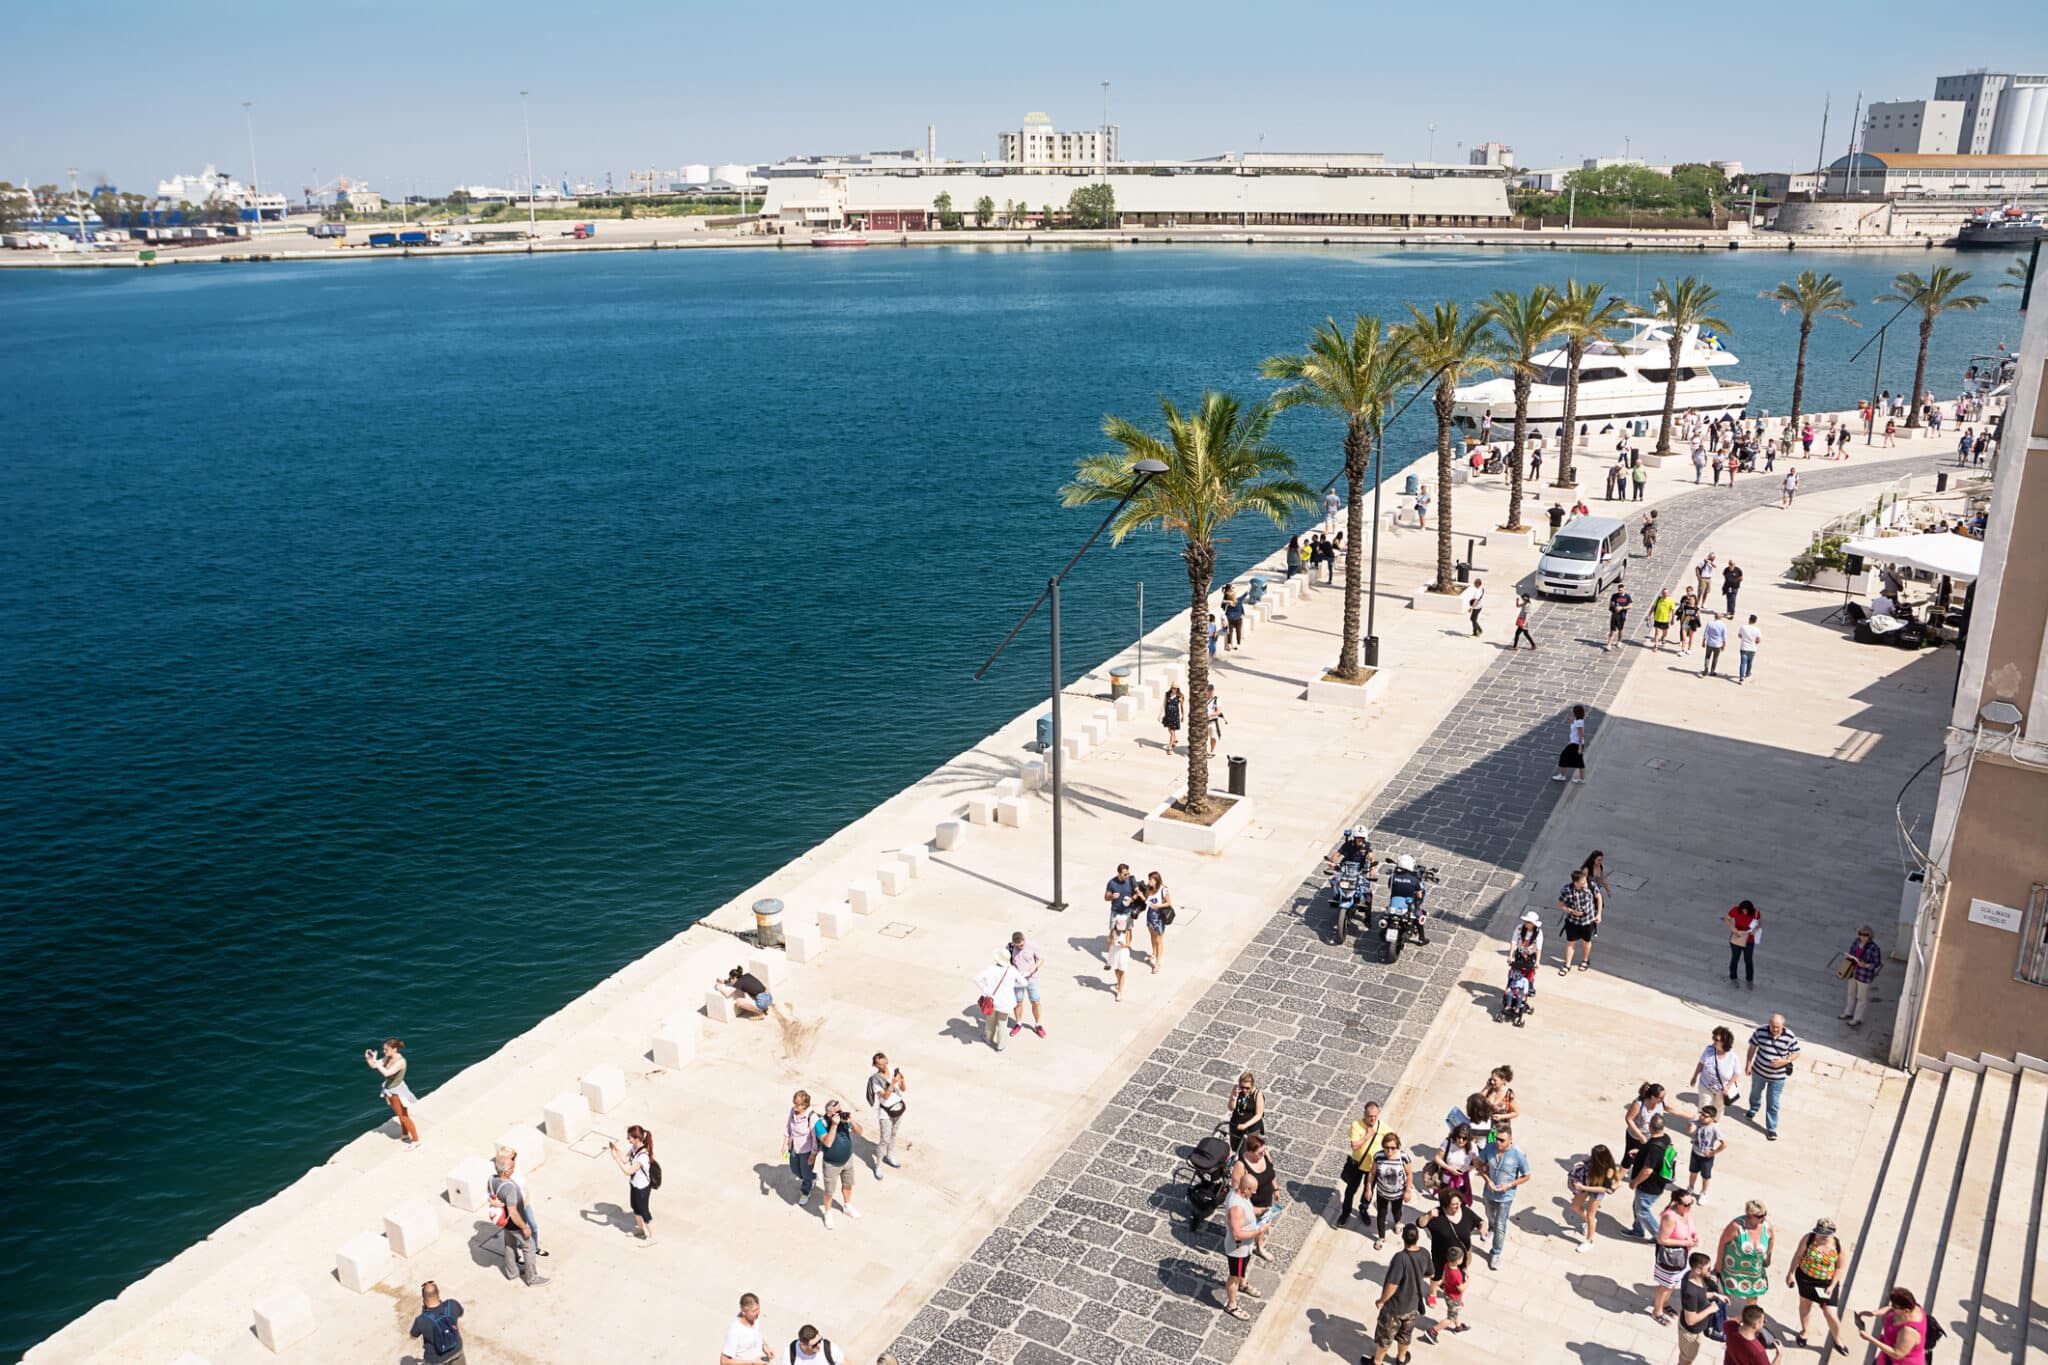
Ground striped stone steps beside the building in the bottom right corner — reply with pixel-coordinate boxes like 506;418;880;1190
1835;1056;2048;1365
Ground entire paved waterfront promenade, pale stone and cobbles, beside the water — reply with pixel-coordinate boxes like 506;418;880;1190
27;376;2048;1365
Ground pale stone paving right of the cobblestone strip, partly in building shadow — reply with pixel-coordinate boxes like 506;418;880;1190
1243;466;1956;1365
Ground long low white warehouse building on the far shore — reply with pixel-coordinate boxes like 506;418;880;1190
762;151;1509;231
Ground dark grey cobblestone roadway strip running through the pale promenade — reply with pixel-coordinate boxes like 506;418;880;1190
891;452;1937;1365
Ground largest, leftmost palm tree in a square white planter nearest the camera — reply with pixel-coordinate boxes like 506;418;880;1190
1059;391;1315;817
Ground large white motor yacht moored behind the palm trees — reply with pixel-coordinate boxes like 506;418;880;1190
1450;317;1749;434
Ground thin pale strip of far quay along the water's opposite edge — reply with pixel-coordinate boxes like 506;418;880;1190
0;219;1952;270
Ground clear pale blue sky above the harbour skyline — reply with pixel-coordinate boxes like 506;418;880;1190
0;0;2048;194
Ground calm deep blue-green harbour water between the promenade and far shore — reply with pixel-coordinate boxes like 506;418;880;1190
0;248;2017;1355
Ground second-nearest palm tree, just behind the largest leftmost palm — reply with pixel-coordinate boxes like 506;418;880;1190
1260;313;1417;681
